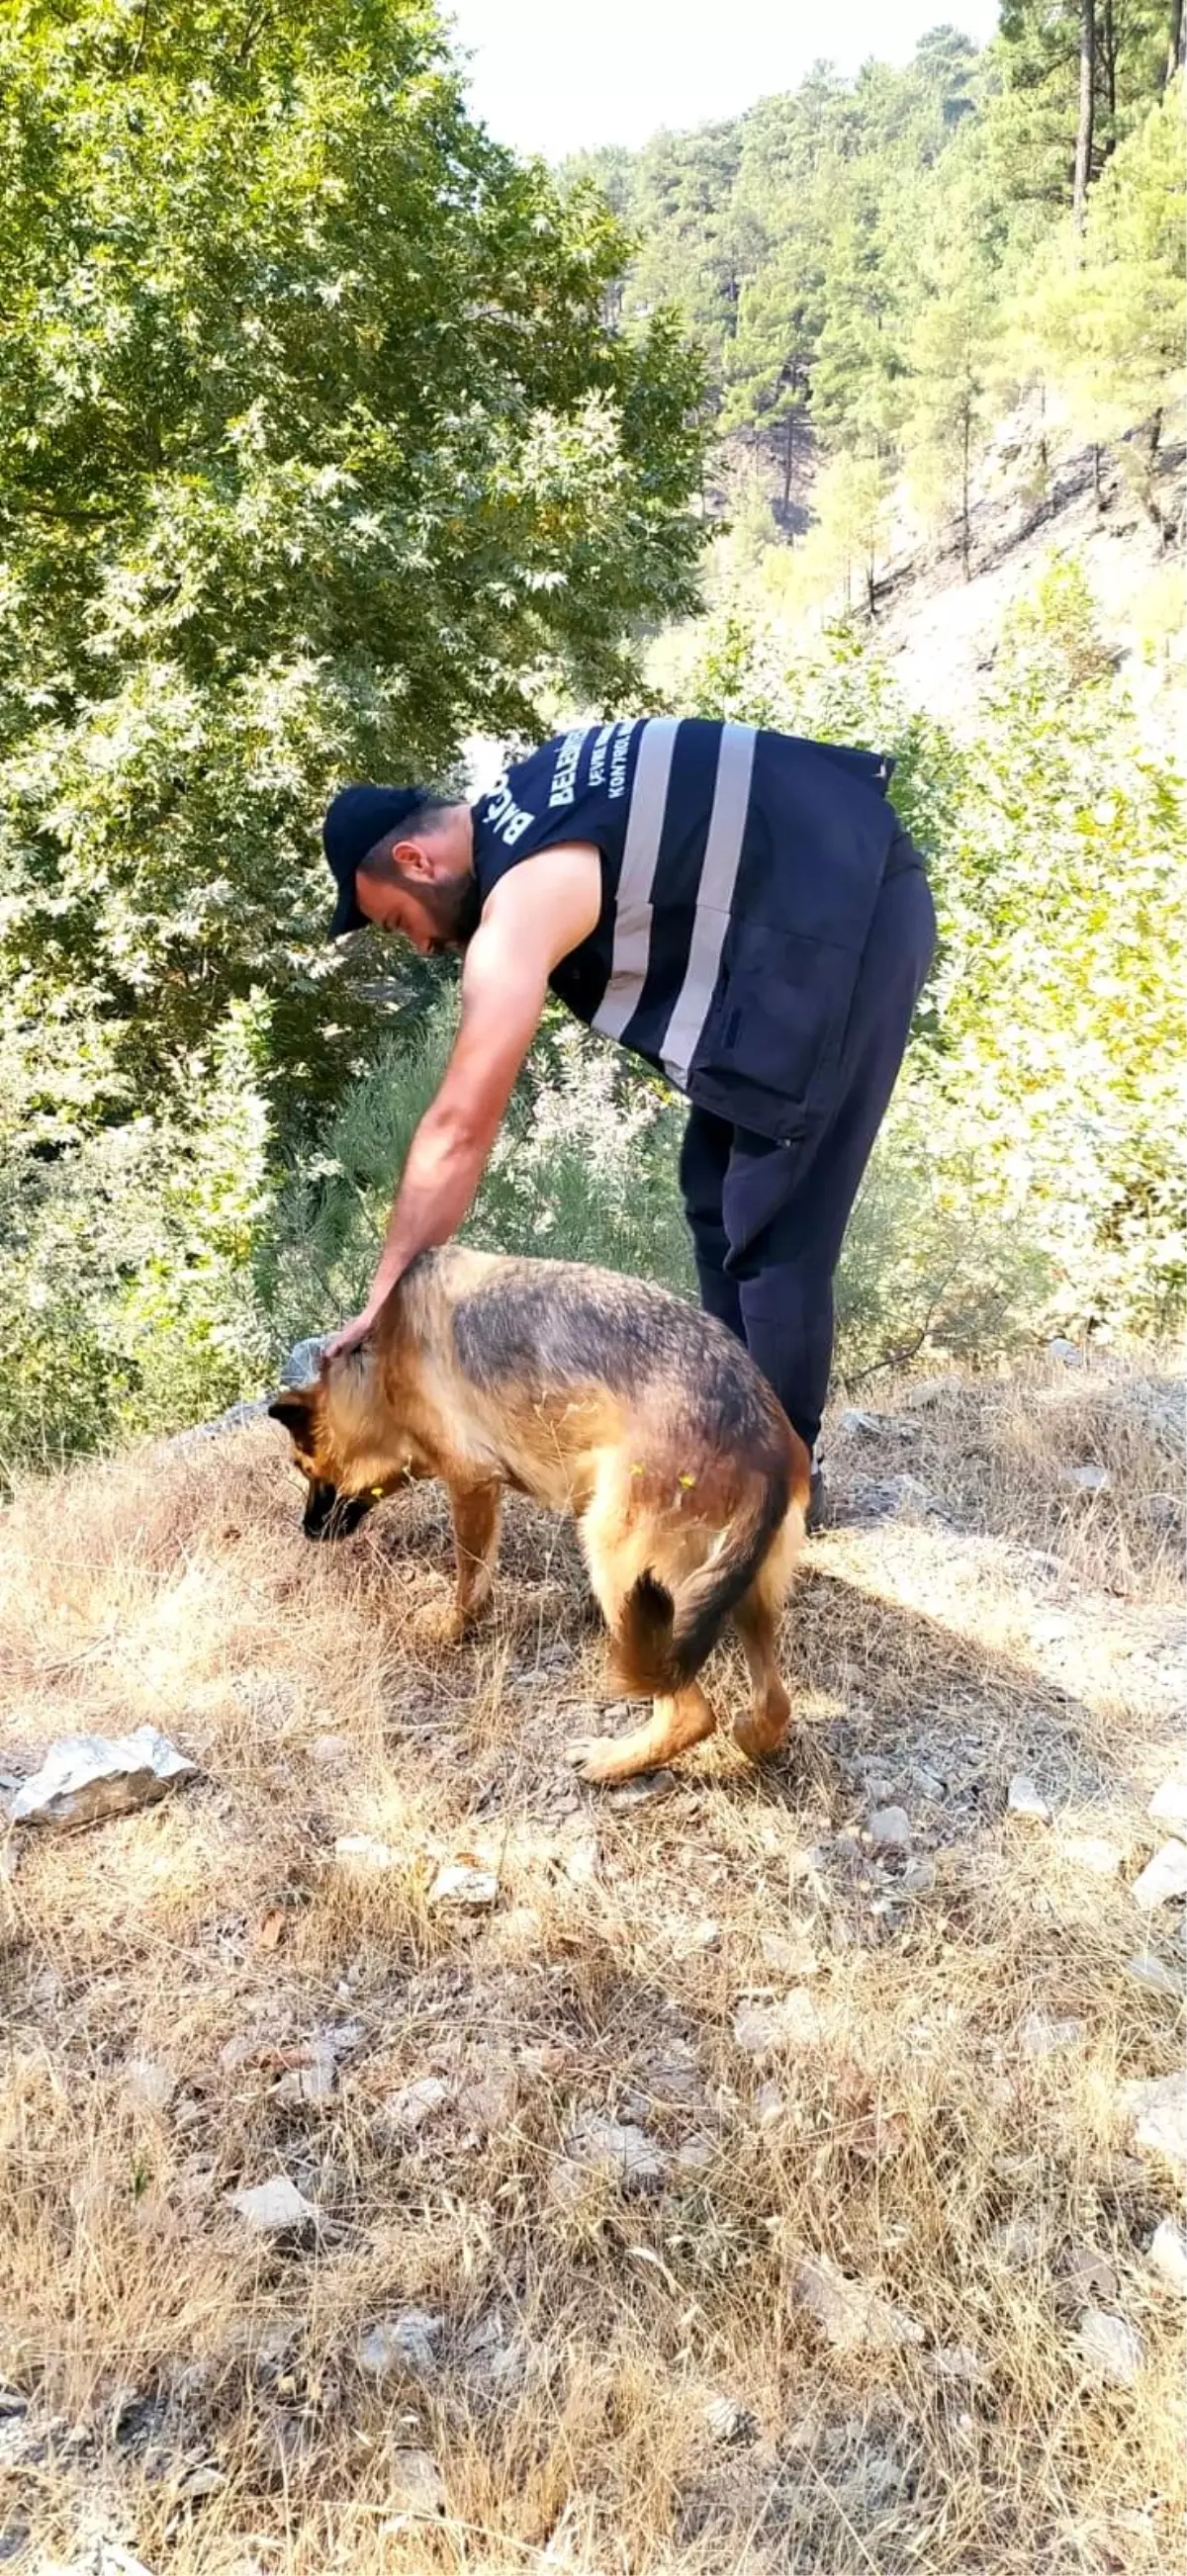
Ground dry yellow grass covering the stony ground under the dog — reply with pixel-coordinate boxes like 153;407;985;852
0;1368;1187;2576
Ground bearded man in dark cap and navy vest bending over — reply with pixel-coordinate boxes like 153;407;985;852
324;716;935;1504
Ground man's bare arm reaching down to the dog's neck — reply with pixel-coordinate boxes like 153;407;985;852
327;843;602;1355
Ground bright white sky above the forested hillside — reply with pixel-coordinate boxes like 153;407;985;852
445;0;996;160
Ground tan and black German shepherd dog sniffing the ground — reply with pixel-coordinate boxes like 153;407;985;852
268;1244;808;1780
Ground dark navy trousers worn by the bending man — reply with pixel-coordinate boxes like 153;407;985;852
680;832;935;1451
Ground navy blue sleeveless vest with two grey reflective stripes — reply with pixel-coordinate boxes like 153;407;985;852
474;716;914;1141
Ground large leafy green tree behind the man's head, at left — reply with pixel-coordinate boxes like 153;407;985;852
0;0;697;1112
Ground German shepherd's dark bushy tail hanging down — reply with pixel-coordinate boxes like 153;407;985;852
613;1473;790;1698
